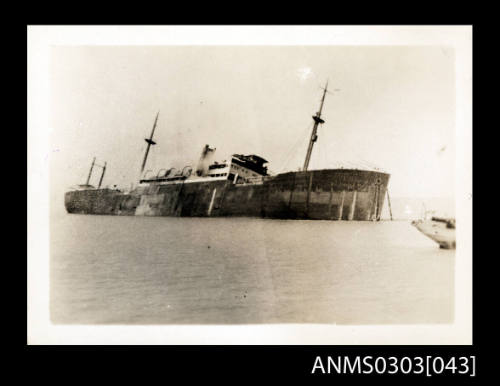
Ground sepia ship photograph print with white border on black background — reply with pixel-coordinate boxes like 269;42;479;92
28;26;472;344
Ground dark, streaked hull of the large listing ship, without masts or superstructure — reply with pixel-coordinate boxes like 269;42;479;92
65;169;390;221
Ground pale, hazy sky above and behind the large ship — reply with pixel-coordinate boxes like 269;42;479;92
50;46;455;197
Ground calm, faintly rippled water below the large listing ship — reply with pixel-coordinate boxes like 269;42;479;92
50;214;455;324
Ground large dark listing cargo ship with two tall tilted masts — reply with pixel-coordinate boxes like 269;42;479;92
64;82;390;221
